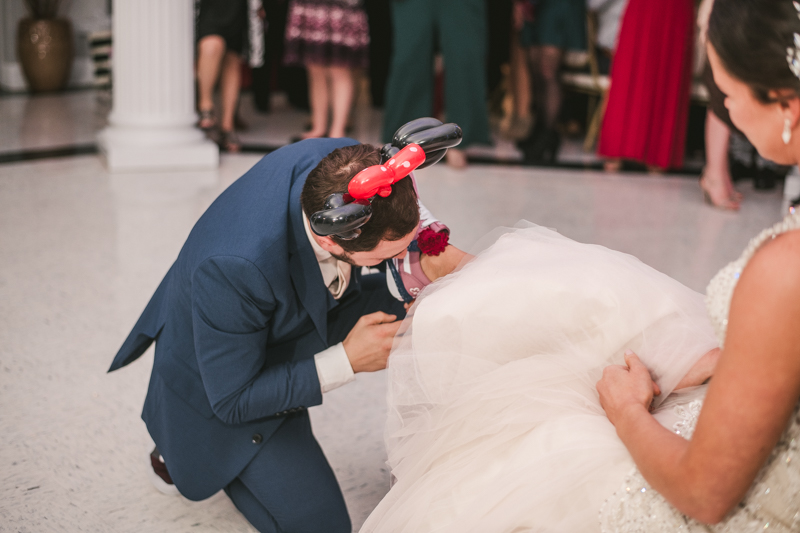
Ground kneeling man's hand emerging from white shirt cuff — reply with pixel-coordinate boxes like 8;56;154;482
342;311;402;373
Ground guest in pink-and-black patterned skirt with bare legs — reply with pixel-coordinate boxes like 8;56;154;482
284;0;370;139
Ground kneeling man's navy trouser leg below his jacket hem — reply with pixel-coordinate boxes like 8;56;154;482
225;411;352;533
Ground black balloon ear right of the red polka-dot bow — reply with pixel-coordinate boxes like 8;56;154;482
381;117;462;170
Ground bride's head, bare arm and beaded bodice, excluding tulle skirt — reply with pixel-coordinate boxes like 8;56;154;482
597;0;800;532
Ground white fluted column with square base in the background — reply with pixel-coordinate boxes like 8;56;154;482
99;0;219;170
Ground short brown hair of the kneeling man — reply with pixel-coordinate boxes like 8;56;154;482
300;144;419;253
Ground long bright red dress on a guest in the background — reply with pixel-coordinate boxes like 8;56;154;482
597;0;695;169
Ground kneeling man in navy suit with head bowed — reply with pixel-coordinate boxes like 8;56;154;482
109;139;460;533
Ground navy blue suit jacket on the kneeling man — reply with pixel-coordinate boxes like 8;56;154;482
109;139;360;500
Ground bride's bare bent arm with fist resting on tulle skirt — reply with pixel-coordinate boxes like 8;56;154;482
597;232;800;523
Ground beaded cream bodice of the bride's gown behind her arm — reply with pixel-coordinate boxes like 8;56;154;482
600;213;800;533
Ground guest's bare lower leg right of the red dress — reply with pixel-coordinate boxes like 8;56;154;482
700;110;742;210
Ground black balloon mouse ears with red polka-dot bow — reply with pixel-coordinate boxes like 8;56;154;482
309;118;462;240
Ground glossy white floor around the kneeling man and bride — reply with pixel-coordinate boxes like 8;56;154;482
0;148;781;532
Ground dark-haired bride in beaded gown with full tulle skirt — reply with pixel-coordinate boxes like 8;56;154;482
361;0;800;533
